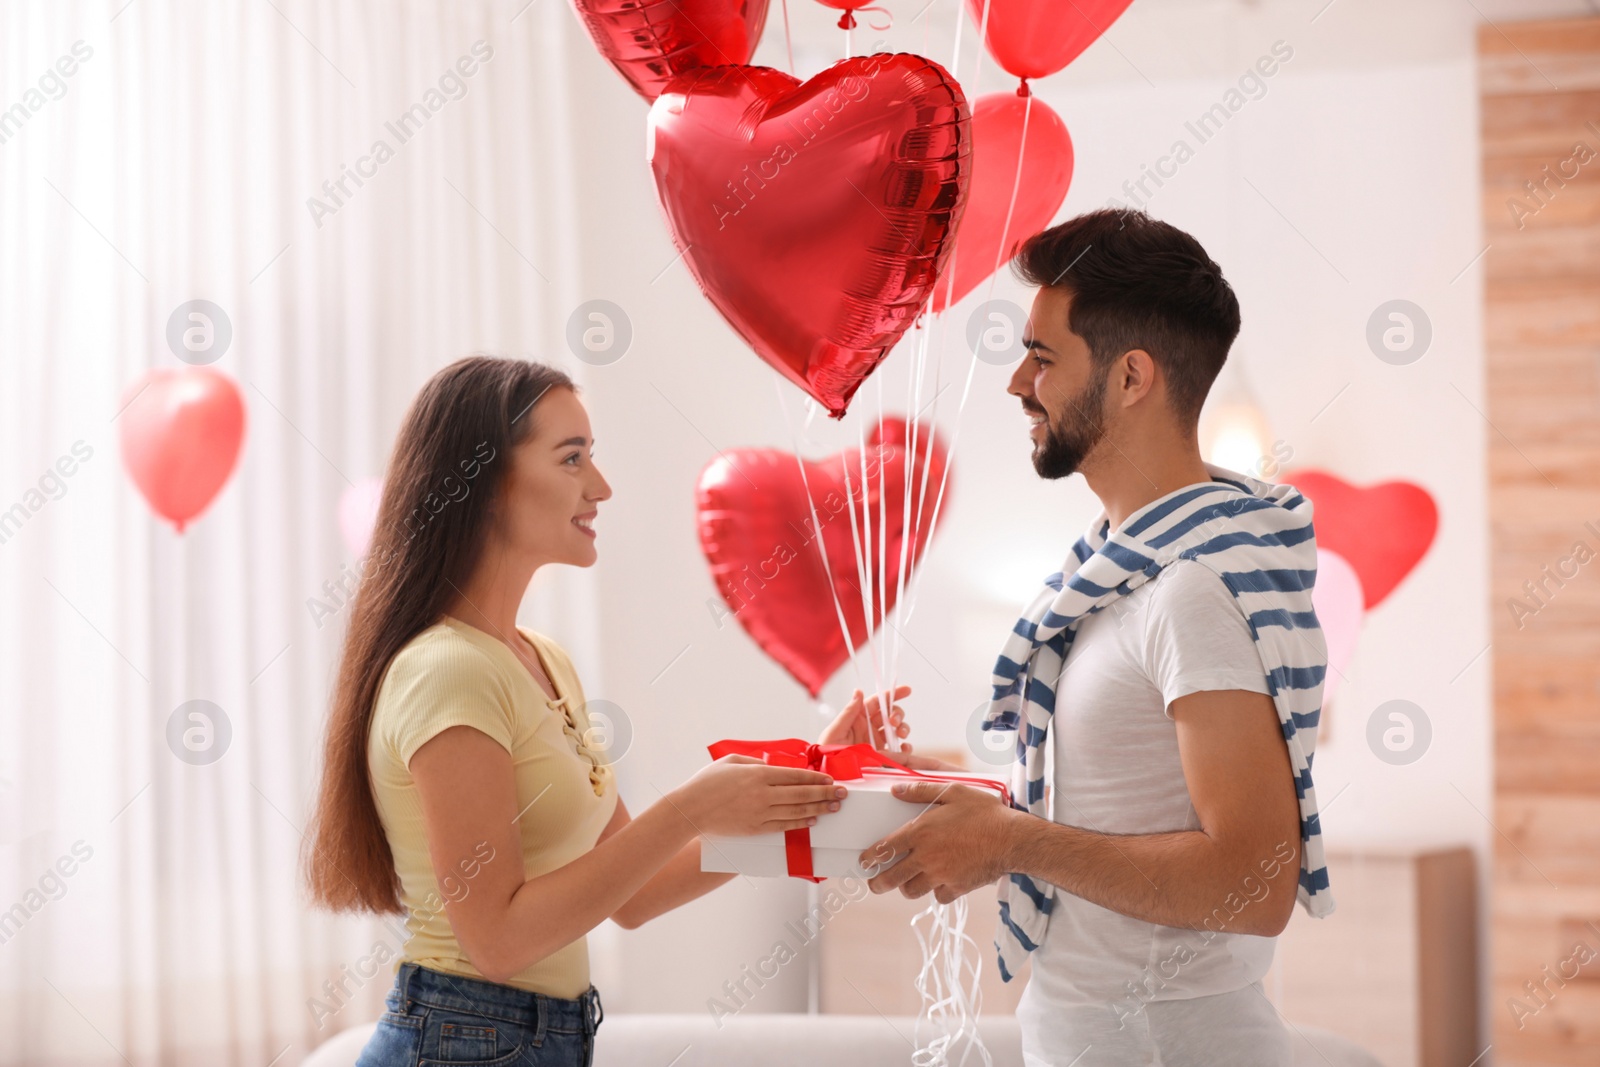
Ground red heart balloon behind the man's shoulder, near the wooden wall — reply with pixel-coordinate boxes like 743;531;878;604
1283;470;1438;611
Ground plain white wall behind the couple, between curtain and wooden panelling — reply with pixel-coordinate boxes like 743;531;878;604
550;0;1536;1011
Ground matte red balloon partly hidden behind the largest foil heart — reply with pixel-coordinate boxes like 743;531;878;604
933;93;1072;312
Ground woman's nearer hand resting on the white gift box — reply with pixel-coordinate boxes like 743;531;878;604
674;755;845;837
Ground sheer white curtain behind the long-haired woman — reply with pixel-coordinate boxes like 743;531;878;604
0;0;597;1067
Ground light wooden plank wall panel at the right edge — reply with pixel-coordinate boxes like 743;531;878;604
1478;19;1600;1067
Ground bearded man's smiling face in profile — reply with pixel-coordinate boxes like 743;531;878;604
1006;288;1106;478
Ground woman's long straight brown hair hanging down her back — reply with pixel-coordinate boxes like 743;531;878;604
302;357;576;913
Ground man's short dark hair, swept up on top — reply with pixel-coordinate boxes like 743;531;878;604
1011;208;1238;422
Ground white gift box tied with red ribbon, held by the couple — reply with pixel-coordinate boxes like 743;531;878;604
701;768;1010;878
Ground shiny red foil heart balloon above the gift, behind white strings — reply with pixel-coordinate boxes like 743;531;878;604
694;419;949;697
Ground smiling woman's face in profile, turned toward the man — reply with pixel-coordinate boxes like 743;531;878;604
498;389;611;566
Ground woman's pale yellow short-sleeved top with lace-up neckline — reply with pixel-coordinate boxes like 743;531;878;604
366;616;616;998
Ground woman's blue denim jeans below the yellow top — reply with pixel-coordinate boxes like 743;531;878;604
355;963;605;1067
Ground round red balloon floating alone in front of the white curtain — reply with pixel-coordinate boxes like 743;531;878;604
117;366;245;533
